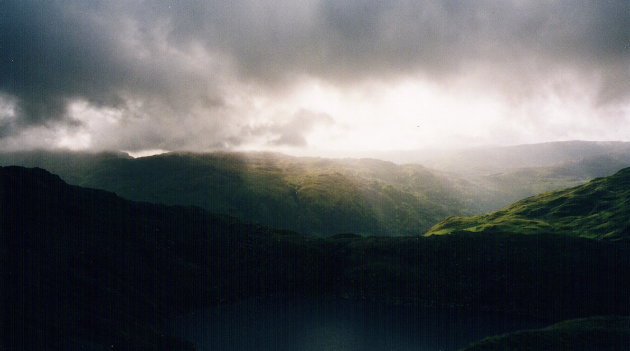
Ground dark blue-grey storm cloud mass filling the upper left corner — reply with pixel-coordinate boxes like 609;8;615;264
0;1;226;136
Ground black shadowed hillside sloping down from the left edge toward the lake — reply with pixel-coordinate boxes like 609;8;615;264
0;167;332;350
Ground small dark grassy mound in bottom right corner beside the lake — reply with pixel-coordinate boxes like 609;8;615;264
462;316;630;351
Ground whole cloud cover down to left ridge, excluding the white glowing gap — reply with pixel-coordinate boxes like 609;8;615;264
0;0;630;150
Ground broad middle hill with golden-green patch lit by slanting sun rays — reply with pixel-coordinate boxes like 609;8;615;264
0;151;489;236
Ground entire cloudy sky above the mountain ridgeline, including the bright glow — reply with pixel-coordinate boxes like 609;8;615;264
0;0;630;154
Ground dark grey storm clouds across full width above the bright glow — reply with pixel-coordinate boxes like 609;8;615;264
0;0;630;147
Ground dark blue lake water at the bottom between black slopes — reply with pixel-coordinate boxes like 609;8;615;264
167;299;548;351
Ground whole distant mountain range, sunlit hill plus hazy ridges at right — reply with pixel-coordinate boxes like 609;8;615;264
0;142;630;236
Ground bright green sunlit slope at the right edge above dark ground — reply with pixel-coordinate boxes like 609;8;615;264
426;168;630;240
